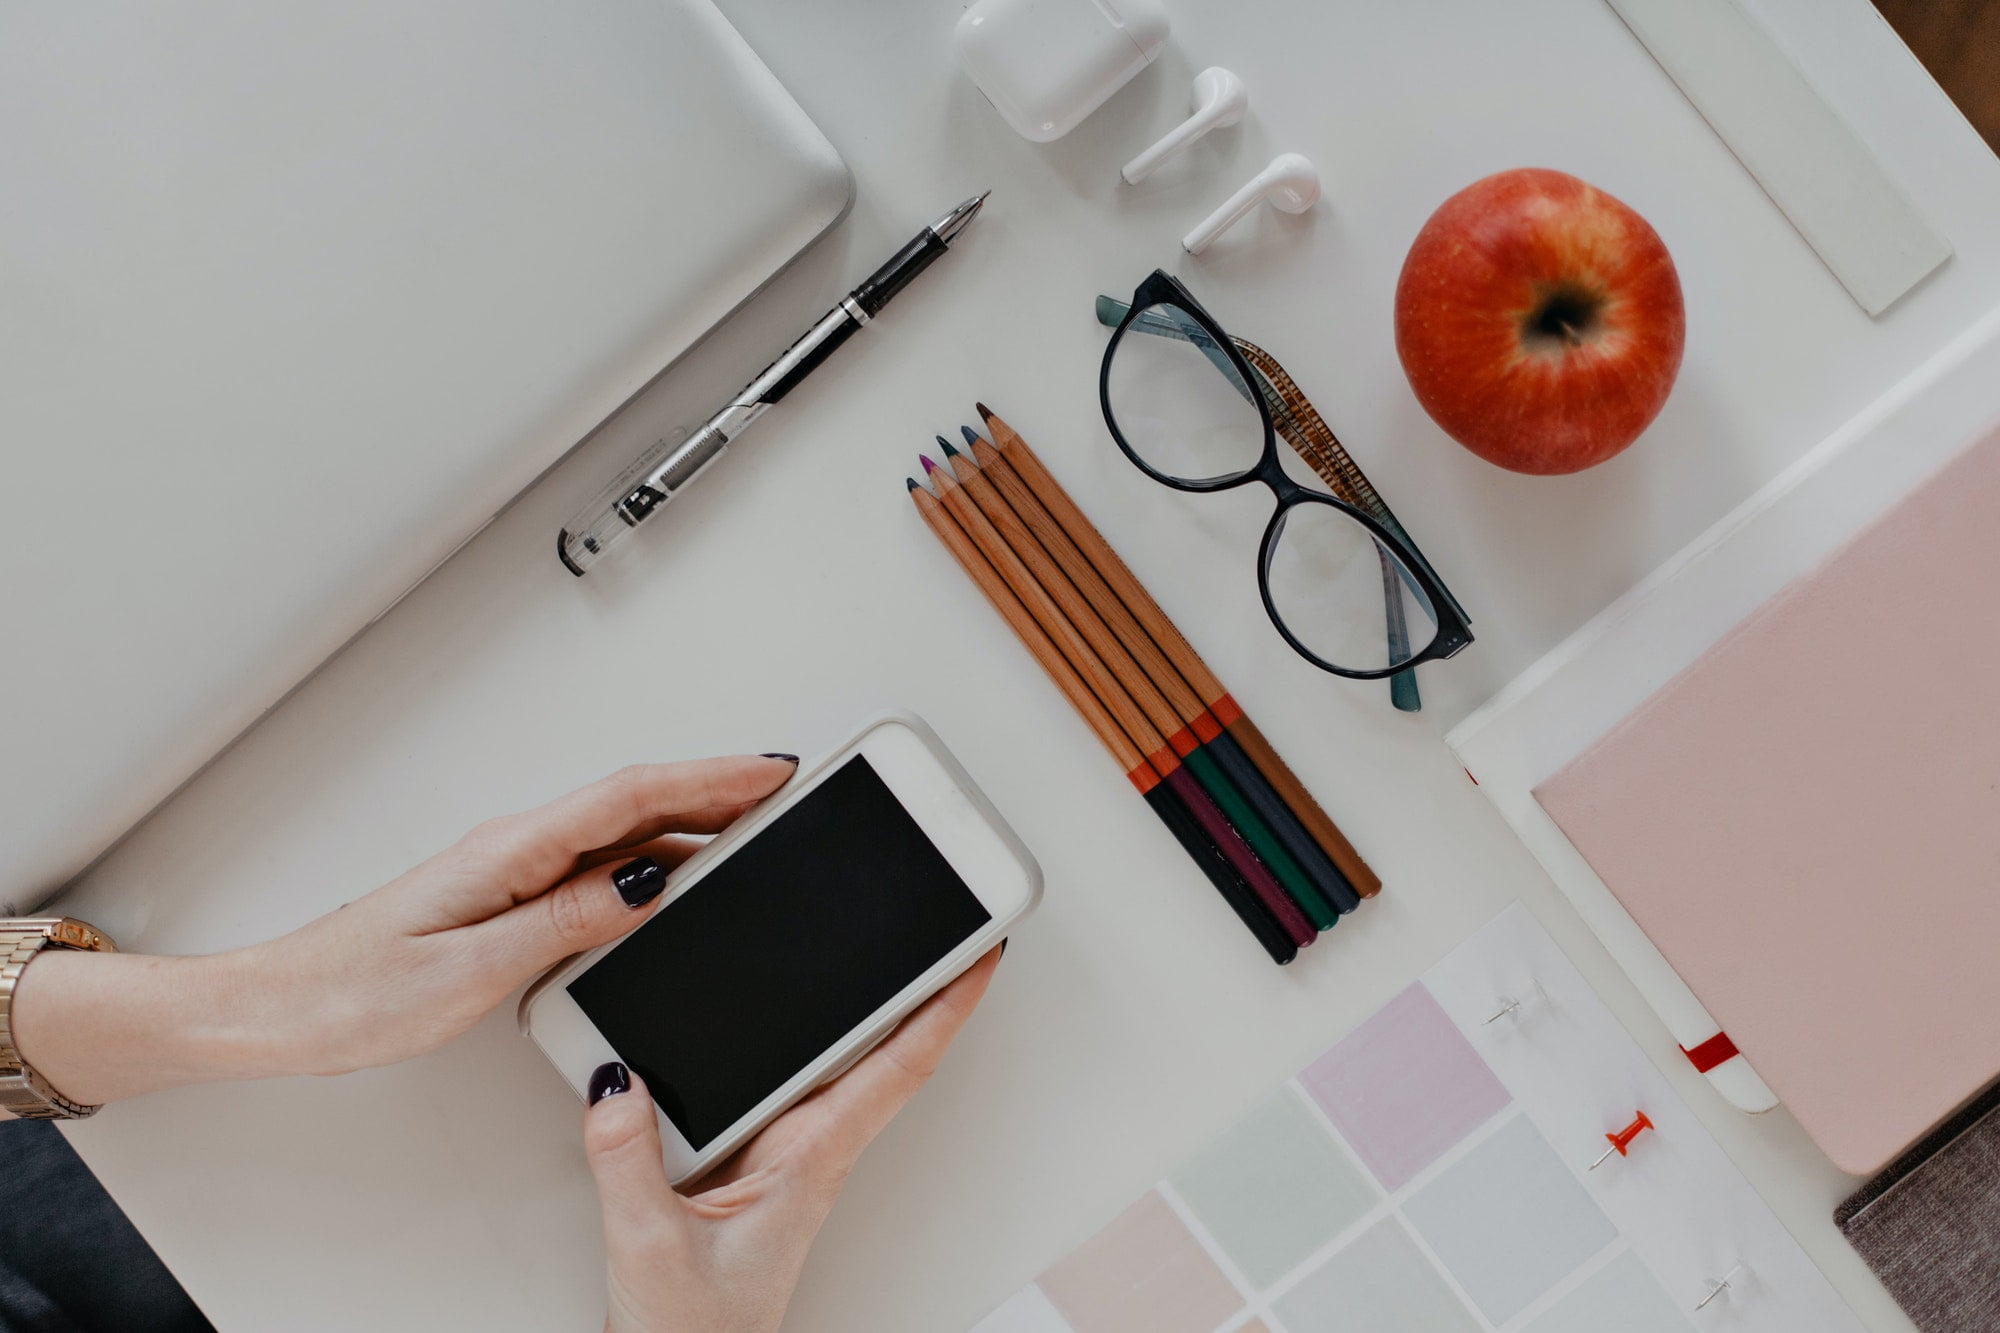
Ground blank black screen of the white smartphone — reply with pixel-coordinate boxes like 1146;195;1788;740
568;755;992;1149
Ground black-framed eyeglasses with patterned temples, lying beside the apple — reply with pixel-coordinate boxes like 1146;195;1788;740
1098;270;1472;709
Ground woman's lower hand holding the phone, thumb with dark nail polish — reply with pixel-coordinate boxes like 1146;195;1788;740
584;949;1000;1333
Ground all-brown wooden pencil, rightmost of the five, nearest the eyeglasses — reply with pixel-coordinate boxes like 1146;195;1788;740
976;402;1382;899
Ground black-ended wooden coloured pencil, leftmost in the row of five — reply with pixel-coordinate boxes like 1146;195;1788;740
908;478;1298;965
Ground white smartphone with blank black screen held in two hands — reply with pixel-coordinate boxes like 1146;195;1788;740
520;715;1042;1185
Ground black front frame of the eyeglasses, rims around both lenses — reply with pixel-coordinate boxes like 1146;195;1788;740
1098;268;1472;681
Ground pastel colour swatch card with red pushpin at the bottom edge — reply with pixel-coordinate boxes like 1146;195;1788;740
974;905;1860;1333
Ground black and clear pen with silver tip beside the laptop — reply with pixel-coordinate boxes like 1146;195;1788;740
556;190;990;578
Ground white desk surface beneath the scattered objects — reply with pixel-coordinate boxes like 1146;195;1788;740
47;0;2000;1333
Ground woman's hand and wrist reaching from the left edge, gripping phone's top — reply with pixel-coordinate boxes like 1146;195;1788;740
12;757;796;1103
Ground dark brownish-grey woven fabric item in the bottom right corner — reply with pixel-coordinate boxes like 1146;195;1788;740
1834;1085;2000;1333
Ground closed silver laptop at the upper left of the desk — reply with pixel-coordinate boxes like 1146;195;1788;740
0;0;852;911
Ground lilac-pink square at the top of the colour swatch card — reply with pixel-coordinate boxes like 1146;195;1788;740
1298;981;1508;1189
